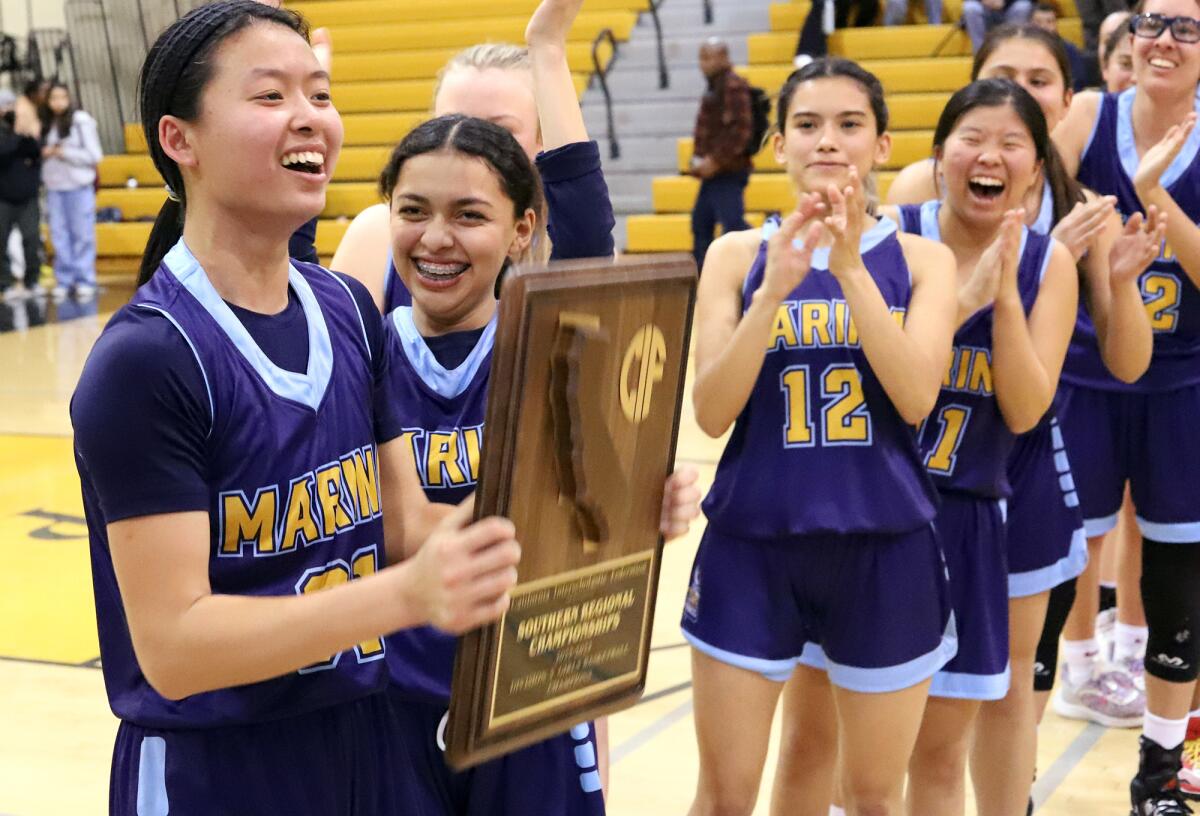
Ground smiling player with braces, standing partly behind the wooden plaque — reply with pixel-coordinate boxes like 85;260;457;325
369;109;700;816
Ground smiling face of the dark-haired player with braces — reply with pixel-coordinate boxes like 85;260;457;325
391;149;535;334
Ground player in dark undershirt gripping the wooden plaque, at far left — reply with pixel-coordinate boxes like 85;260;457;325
71;0;520;816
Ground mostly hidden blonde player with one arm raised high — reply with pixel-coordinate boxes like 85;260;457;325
331;0;614;314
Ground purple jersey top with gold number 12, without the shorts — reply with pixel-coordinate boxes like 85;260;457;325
703;218;936;539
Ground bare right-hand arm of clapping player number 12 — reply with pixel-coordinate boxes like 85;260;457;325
826;174;956;425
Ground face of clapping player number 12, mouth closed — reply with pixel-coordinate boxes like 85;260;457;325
774;77;892;193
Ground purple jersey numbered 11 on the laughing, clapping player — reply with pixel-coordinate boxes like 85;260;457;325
900;200;1054;498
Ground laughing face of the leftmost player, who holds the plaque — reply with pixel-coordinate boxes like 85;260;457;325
158;23;342;232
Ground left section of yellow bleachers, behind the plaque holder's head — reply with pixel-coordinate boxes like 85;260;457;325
96;0;633;274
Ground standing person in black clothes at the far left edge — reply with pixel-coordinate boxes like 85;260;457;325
0;87;42;300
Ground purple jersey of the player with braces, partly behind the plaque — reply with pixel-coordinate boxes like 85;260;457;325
384;306;496;703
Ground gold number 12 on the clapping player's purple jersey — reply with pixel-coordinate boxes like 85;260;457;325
779;365;871;448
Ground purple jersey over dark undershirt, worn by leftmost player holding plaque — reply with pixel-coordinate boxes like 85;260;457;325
83;241;385;728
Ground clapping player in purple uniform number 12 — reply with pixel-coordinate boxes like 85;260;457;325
683;59;956;814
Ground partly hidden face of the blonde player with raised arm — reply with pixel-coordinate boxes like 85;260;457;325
433;67;541;161
